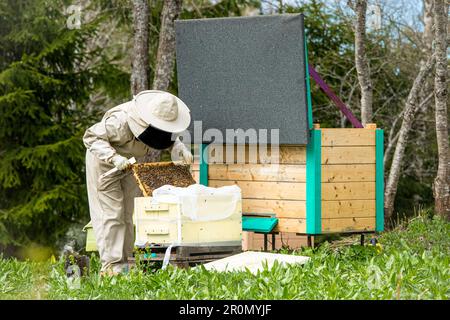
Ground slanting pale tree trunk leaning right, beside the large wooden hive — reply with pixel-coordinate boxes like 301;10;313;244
384;55;435;225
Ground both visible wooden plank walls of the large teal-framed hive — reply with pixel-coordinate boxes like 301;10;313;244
192;128;375;233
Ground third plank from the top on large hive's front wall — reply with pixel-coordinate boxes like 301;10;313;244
209;180;306;200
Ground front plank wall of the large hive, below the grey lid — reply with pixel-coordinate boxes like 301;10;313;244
192;145;306;233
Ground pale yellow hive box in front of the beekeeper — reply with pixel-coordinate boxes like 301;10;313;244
134;195;242;246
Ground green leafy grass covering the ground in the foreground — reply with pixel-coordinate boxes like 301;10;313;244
0;212;450;299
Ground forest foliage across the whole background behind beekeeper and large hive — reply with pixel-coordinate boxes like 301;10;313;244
0;0;437;252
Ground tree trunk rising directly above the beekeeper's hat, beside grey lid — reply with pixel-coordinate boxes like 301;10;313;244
152;0;182;91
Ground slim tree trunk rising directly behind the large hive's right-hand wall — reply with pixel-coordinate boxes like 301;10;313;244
353;0;373;126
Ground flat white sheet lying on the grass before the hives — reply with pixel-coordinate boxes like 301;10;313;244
199;251;311;274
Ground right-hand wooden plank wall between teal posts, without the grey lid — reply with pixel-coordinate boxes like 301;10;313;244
321;128;375;233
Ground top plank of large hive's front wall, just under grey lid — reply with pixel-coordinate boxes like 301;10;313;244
194;145;306;164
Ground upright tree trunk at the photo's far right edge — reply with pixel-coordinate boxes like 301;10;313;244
433;0;450;219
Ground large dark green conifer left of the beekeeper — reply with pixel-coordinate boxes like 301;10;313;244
0;0;107;247
